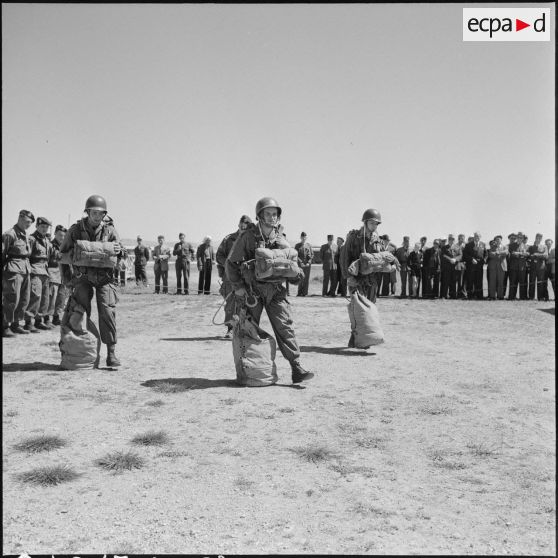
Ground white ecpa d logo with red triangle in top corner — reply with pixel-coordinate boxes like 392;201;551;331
463;8;551;41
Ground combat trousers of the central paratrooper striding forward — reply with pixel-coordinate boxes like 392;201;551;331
246;283;300;362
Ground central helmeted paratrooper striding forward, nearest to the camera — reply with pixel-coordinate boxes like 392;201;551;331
225;197;314;384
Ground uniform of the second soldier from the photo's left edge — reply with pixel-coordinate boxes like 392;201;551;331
25;223;52;329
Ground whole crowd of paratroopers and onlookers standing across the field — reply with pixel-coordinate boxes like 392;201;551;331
2;195;555;383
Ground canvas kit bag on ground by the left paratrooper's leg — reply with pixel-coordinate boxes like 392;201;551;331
58;299;101;370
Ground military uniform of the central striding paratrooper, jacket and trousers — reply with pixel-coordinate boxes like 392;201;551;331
225;224;300;365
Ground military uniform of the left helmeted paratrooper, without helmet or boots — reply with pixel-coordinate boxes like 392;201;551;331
60;217;126;346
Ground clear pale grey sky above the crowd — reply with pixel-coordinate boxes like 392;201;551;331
2;3;555;245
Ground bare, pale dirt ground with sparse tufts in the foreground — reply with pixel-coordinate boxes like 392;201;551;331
3;273;556;555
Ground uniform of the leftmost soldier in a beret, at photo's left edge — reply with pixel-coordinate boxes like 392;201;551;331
2;220;34;329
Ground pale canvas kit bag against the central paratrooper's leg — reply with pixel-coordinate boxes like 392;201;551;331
232;309;277;387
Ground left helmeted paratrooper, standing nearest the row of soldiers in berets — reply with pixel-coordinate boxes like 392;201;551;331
60;195;127;366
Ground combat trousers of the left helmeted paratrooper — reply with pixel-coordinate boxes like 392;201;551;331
71;270;118;345
